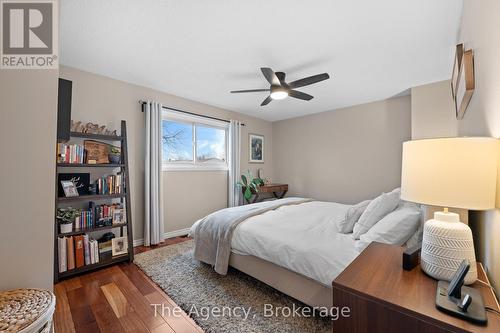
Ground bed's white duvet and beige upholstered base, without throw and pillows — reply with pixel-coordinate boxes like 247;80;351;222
191;199;422;307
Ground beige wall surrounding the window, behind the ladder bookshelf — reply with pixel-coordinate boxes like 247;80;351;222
60;66;273;239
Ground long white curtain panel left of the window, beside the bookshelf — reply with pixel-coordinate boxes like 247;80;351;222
143;102;164;246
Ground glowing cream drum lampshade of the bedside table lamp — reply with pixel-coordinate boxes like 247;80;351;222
401;138;499;210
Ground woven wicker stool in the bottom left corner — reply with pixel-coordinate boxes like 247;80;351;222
0;289;56;333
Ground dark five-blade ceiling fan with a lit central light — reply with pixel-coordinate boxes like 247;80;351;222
231;67;330;106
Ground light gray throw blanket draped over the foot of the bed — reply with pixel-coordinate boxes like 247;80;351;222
194;198;312;275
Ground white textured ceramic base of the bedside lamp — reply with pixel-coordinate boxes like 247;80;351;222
420;212;477;284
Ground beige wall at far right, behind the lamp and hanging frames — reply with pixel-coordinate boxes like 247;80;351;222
457;0;500;291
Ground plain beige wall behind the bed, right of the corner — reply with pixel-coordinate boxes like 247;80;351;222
273;96;411;203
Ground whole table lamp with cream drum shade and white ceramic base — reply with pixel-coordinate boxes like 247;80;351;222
401;137;499;284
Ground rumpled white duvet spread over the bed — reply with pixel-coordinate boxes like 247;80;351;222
191;201;360;286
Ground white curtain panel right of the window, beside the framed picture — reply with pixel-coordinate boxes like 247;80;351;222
227;120;241;207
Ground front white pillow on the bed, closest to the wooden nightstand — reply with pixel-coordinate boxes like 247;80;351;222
356;207;420;248
